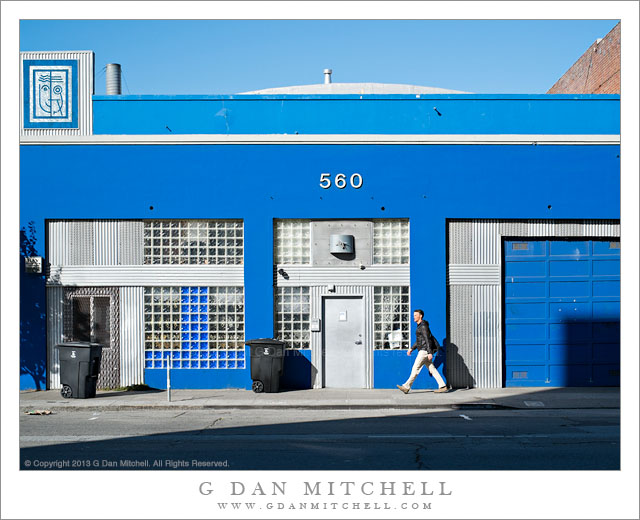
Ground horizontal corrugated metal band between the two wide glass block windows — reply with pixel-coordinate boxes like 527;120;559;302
47;265;244;287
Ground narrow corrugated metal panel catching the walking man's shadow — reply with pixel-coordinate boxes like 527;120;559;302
446;285;476;388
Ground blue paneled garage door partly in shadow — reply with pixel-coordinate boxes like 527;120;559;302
504;239;620;387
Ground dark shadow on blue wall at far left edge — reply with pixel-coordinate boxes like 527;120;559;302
20;222;47;390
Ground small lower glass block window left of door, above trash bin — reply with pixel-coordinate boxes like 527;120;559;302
276;287;311;349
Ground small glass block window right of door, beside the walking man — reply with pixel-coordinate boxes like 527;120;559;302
373;286;411;349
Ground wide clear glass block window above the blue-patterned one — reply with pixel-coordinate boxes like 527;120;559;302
144;220;244;265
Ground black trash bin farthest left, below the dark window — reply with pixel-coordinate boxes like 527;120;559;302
56;341;102;399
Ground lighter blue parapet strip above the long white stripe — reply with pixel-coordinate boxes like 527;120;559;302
93;94;620;135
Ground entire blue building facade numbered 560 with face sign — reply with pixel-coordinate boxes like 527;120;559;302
20;53;620;389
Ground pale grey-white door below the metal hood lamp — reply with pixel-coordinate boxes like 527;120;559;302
322;297;366;388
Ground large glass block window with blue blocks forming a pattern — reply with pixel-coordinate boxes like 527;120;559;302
144;287;245;368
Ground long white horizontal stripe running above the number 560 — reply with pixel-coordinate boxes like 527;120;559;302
20;134;620;145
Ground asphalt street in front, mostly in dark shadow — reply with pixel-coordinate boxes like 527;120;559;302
20;409;620;470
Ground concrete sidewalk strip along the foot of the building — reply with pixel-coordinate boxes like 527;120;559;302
20;388;620;412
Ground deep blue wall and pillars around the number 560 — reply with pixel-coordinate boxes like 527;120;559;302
20;145;620;388
